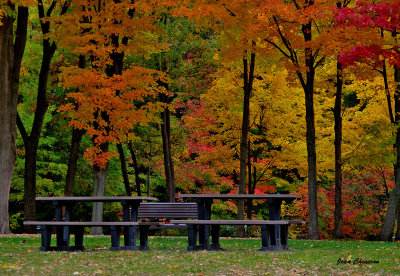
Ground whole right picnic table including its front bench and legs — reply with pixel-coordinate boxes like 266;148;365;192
178;194;303;251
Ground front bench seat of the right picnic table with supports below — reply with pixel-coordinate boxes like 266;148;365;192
171;220;305;251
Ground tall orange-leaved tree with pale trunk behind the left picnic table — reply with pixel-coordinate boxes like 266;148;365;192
55;0;168;234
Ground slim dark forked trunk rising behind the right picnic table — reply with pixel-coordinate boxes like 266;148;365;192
236;52;256;237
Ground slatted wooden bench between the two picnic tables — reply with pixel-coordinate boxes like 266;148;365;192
138;202;198;229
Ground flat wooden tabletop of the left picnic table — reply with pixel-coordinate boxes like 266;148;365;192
36;196;158;202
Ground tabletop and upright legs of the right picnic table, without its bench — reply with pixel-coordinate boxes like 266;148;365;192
178;194;300;250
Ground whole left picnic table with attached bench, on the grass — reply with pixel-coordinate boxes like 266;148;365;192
26;196;158;250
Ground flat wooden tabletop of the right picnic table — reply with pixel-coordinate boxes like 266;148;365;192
178;194;300;199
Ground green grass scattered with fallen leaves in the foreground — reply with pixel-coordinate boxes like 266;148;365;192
0;235;400;275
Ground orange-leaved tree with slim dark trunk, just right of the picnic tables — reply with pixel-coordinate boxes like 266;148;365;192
260;0;342;239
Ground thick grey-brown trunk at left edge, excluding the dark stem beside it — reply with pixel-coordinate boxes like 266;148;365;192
0;13;17;234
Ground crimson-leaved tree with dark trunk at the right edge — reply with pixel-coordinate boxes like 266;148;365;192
337;1;400;241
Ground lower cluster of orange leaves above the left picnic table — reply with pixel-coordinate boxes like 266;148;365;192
60;67;166;145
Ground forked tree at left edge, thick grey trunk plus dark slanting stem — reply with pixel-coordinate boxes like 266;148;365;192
0;2;28;234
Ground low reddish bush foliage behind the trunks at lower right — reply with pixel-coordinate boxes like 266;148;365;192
293;171;394;239
